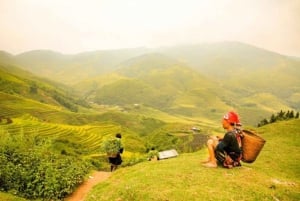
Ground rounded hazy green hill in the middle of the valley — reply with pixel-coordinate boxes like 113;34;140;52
78;54;237;122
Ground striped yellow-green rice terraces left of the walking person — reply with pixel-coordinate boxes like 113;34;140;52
0;115;120;153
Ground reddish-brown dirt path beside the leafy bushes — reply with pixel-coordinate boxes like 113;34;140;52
66;171;111;201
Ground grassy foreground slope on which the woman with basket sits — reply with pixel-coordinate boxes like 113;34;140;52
86;120;300;201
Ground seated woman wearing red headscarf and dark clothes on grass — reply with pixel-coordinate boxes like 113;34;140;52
203;112;242;168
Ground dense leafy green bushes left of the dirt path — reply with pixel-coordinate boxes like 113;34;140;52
0;133;90;200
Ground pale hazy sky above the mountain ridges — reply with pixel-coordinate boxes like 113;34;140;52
0;0;300;56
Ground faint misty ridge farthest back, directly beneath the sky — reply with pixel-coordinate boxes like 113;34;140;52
0;42;300;84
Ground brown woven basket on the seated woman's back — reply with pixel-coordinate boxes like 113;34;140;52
242;130;266;163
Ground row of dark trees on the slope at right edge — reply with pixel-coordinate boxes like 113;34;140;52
257;110;299;127
